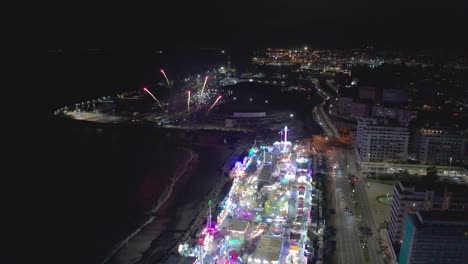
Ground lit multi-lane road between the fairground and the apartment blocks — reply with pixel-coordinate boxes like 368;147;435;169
313;83;384;264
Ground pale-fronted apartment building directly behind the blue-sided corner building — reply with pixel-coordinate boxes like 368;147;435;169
387;182;468;250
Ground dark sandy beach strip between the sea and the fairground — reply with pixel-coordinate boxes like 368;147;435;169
102;136;245;264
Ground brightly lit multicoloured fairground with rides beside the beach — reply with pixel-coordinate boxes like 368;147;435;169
178;127;314;264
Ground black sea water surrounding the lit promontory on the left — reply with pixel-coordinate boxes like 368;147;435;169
8;49;241;263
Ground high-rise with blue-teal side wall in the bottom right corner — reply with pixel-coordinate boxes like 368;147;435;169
399;211;468;264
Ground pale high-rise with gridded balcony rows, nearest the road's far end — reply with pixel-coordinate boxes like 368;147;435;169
356;118;410;162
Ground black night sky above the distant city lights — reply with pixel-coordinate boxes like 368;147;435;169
12;0;468;47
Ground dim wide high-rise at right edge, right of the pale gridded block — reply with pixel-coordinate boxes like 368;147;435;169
416;128;466;164
